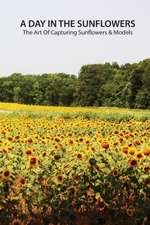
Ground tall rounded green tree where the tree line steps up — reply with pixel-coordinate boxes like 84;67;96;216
76;63;111;106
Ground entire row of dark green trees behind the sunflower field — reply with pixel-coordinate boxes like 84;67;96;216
0;59;150;109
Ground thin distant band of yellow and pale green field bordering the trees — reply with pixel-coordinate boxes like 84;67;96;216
0;103;150;120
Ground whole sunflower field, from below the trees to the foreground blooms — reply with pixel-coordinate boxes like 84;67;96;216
0;103;150;225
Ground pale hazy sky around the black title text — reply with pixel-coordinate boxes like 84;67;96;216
0;0;150;76
